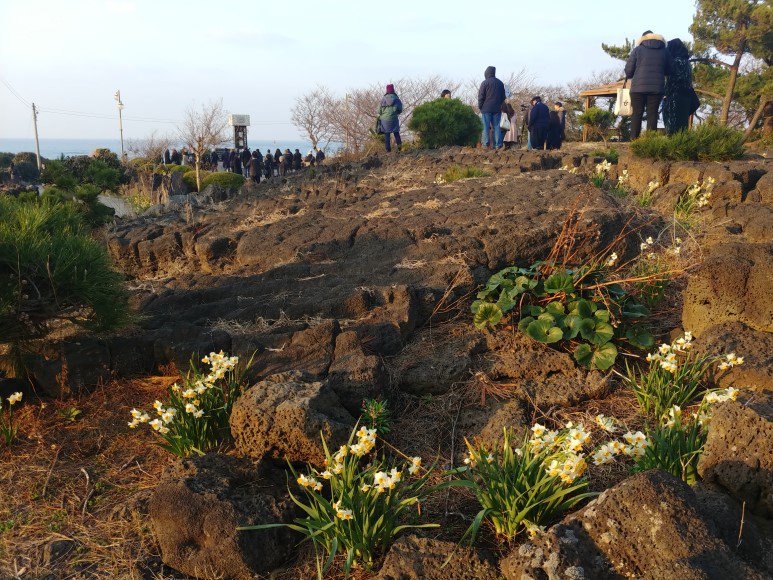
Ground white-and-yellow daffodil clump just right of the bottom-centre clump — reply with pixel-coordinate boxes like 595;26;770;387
460;425;595;540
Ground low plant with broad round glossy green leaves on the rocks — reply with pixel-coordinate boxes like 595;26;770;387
471;255;654;370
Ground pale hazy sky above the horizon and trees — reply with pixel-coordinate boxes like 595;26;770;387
0;0;694;140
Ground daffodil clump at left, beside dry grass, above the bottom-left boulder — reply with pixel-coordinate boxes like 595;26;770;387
129;352;247;457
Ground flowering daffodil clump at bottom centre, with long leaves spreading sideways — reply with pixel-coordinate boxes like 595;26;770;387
244;427;457;578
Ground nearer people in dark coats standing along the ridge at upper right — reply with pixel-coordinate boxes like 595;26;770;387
376;30;700;152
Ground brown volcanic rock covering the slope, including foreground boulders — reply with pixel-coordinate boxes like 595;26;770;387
0;143;773;579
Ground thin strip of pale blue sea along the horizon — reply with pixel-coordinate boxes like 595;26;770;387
0;138;322;161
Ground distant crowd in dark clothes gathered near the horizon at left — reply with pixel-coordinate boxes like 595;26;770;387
162;147;325;183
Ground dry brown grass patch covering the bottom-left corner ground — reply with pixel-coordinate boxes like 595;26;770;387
0;377;175;578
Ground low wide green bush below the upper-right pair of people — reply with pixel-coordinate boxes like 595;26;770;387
631;124;745;161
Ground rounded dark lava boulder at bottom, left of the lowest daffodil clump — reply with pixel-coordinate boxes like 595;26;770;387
149;453;296;580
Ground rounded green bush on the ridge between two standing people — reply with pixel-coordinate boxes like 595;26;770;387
408;99;481;149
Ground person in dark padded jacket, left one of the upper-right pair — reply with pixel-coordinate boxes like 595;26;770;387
625;30;672;139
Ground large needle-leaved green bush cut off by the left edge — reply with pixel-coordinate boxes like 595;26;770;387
0;197;128;343
